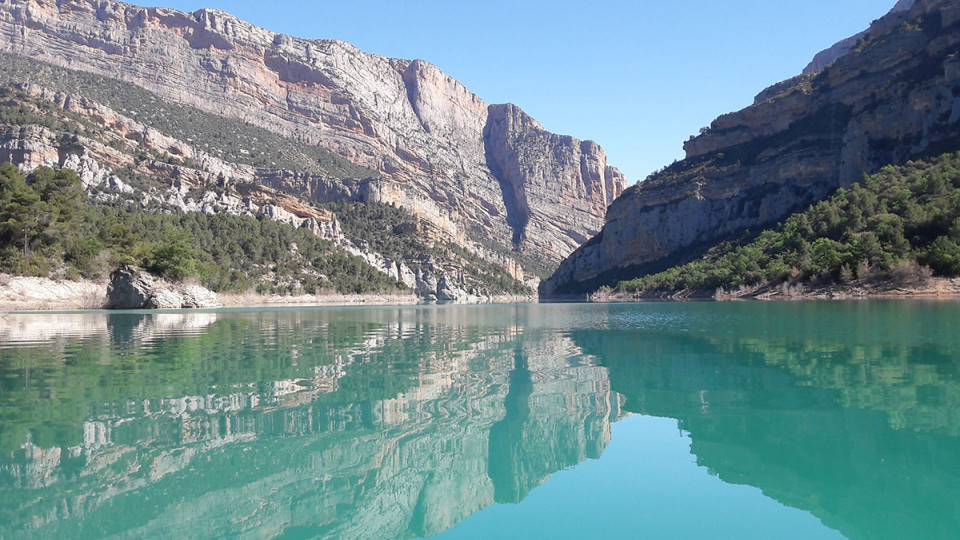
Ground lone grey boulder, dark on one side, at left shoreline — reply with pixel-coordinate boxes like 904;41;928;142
106;266;222;309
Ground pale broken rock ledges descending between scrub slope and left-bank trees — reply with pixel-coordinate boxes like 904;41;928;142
0;85;524;302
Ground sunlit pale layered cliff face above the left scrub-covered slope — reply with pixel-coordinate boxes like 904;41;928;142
0;0;625;272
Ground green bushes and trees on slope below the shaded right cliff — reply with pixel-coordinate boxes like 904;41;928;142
617;153;960;291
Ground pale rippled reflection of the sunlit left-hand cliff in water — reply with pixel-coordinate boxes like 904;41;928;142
0;307;620;538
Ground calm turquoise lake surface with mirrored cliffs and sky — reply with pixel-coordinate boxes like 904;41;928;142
0;301;960;539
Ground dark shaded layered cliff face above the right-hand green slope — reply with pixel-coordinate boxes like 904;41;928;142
541;0;960;295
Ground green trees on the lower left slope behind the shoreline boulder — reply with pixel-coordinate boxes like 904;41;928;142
0;163;403;293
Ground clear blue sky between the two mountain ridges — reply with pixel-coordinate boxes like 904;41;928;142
152;0;896;182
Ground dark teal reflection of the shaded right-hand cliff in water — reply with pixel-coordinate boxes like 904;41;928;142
573;301;960;539
